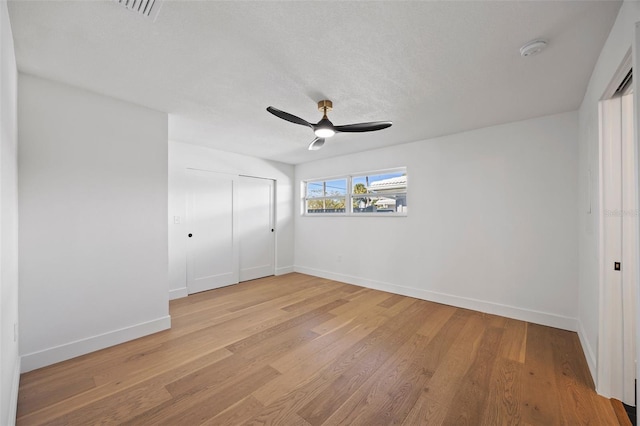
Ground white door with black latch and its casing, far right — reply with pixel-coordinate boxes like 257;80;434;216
597;89;638;405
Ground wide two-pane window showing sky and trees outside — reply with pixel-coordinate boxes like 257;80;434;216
303;168;407;216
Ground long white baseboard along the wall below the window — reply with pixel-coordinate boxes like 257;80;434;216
295;266;577;331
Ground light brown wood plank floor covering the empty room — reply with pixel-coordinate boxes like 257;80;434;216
17;274;619;426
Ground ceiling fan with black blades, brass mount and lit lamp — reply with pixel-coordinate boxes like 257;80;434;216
267;100;392;151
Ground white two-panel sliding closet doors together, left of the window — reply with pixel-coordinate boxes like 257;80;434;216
185;169;275;294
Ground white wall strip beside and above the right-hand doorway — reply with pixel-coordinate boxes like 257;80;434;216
578;1;640;378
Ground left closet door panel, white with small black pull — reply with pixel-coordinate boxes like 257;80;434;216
185;170;239;294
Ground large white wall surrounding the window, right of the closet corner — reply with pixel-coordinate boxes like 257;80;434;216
295;112;578;330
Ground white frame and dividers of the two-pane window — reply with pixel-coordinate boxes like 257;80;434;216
300;167;409;217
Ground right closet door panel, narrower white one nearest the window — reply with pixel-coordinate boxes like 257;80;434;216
236;176;275;281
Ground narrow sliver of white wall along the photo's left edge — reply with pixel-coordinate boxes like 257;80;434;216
0;1;20;425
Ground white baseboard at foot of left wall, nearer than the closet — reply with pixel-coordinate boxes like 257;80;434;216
21;315;171;373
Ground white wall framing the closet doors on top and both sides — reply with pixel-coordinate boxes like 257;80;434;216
168;141;294;299
